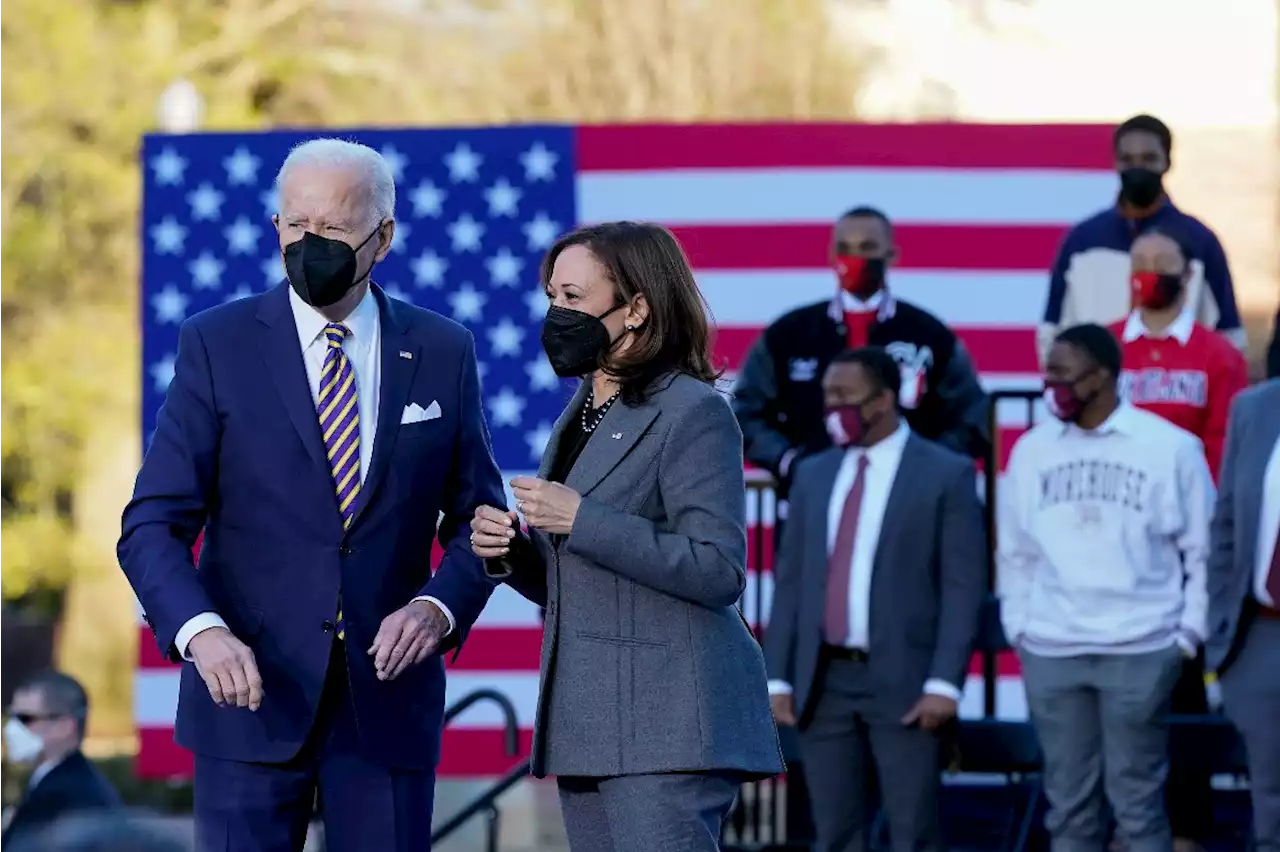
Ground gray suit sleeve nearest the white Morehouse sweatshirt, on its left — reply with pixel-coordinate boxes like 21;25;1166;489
929;455;987;690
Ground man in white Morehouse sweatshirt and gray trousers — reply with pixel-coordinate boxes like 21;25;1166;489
997;319;1213;852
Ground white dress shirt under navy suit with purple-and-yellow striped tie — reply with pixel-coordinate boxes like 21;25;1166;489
173;288;457;660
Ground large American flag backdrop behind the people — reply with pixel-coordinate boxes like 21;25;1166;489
134;124;1115;777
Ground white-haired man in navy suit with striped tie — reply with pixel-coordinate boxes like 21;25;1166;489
118;139;503;852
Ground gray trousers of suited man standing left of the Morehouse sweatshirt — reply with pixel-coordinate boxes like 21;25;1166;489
800;652;947;852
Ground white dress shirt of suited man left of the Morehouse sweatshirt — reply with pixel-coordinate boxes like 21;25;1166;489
769;422;960;701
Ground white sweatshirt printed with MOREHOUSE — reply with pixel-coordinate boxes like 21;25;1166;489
996;404;1213;656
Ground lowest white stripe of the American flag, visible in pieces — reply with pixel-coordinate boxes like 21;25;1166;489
133;670;1027;730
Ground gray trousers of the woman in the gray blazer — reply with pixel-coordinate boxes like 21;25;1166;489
557;773;739;852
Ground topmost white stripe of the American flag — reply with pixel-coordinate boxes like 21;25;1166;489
577;168;1116;225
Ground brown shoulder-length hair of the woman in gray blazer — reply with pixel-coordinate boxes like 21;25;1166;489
541;221;721;406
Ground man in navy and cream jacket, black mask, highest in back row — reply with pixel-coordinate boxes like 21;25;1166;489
1037;115;1245;363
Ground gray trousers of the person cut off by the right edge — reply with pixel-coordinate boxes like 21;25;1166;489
1220;618;1280;852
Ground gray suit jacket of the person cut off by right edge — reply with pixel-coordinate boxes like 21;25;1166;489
1204;379;1280;673
